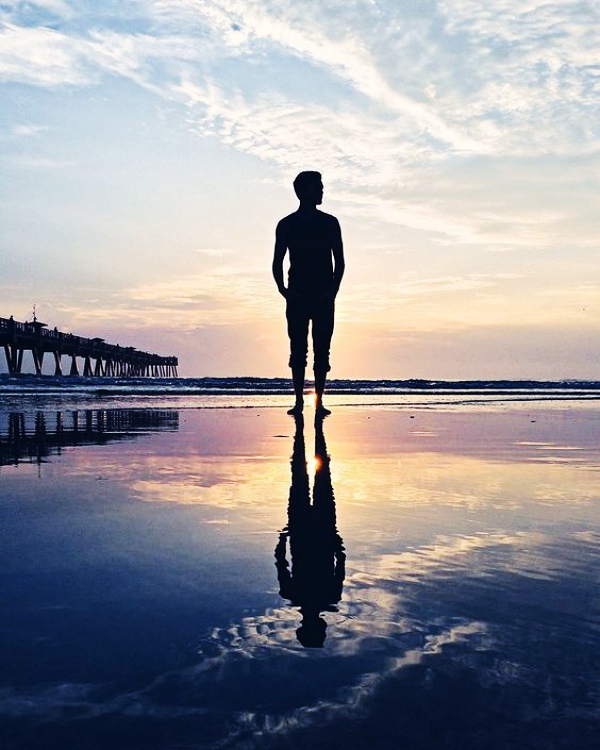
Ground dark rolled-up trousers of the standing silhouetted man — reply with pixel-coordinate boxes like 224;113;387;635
285;297;335;372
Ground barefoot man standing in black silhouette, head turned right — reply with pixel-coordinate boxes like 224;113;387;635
273;172;345;417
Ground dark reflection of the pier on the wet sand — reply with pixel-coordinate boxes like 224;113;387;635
0;409;179;466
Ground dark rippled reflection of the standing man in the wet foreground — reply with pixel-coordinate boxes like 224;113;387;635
275;417;346;648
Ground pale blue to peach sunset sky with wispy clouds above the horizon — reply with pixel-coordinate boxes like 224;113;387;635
0;0;600;379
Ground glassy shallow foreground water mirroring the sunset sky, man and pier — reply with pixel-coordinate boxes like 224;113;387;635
0;408;600;750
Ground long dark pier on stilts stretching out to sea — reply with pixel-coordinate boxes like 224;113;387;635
0;317;179;378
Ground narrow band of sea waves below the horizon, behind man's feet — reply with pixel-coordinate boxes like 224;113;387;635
0;375;600;419
